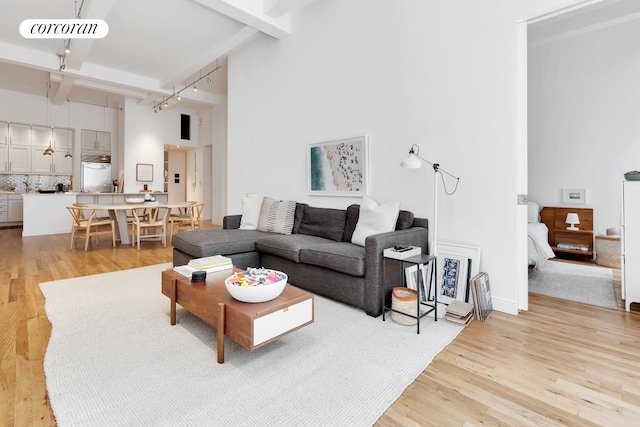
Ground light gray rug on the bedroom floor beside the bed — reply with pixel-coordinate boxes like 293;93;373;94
529;261;618;309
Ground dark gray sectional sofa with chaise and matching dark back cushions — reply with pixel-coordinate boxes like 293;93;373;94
171;203;429;317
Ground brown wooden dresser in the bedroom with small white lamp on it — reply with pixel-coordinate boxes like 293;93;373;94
540;207;593;260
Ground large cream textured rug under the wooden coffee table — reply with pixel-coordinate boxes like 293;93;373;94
40;264;462;426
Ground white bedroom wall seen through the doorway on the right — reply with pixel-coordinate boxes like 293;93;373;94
529;17;640;233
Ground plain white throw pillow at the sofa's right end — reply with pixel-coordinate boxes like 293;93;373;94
351;196;400;246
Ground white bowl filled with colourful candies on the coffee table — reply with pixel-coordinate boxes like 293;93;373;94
224;267;288;303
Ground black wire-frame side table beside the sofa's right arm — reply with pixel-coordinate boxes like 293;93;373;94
381;254;438;334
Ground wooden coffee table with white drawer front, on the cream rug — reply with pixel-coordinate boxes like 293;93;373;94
162;269;314;363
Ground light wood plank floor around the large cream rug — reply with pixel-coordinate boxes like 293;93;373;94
0;229;640;426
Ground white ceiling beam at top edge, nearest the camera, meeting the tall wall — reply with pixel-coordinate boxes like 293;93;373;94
193;0;291;39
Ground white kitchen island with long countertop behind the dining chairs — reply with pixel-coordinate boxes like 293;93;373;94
22;192;168;240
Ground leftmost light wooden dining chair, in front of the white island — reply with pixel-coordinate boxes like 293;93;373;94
67;205;116;252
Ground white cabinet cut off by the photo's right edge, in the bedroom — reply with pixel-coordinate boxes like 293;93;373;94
620;181;640;311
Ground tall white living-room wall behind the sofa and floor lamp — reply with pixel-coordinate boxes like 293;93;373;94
227;0;576;313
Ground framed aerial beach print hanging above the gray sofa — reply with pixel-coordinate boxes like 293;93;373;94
307;135;368;197
